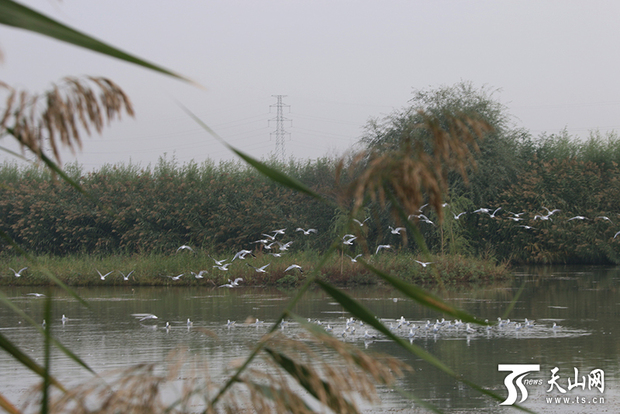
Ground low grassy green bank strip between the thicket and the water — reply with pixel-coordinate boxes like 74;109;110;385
0;251;511;286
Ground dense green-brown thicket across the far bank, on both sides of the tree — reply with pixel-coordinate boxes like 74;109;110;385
0;129;620;263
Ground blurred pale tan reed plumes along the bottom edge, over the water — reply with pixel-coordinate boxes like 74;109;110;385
22;326;409;414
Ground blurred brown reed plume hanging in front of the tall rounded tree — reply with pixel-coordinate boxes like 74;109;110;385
337;111;492;222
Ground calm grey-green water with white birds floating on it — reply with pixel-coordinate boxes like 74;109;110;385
0;267;620;412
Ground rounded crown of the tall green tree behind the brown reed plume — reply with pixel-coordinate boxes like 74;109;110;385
361;82;529;205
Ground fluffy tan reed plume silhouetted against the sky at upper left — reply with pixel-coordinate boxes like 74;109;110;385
0;77;134;162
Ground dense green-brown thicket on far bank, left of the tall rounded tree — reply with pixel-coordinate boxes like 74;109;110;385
0;158;334;255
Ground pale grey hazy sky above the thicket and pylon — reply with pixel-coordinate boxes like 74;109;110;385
0;0;620;169
